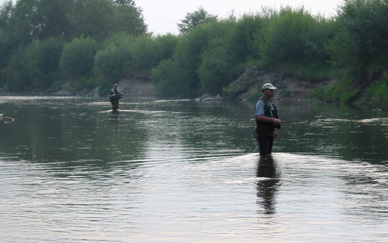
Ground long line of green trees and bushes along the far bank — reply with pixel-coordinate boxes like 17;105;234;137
0;0;388;108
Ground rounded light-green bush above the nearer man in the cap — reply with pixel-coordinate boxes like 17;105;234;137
258;7;333;69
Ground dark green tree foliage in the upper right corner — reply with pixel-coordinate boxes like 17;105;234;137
328;0;388;73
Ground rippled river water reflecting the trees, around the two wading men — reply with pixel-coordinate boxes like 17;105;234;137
0;96;388;242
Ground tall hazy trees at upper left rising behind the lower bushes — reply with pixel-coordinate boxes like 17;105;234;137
0;0;146;44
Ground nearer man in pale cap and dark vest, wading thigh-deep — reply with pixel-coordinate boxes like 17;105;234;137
255;83;281;156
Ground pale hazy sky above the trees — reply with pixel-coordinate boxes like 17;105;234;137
0;0;343;34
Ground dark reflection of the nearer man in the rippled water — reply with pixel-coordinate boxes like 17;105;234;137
257;156;280;214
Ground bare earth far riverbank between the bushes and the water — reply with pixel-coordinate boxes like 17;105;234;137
0;65;346;101
